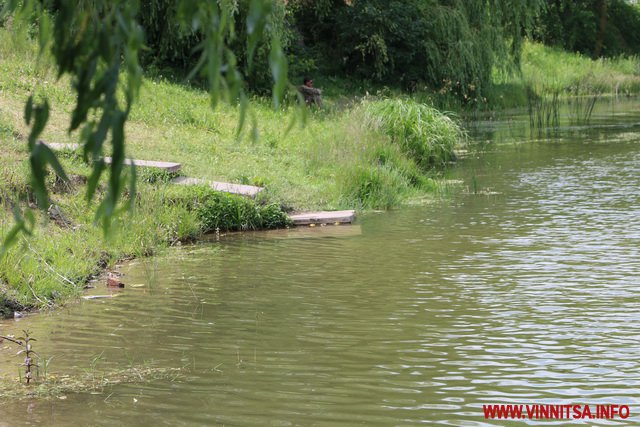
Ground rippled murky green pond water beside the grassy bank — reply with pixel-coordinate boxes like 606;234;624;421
0;100;640;426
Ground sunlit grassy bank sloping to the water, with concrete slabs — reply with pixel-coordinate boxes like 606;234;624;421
0;30;464;314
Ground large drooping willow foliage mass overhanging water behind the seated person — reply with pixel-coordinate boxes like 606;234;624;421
290;0;542;100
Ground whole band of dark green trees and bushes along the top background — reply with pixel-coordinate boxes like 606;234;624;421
20;0;640;105
